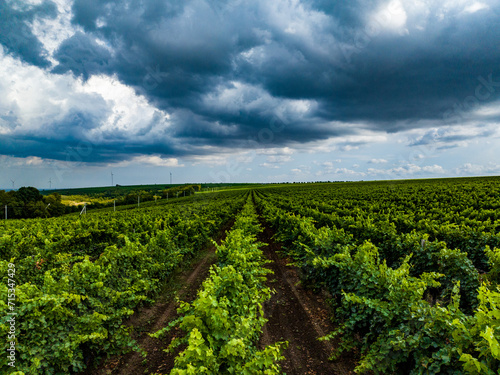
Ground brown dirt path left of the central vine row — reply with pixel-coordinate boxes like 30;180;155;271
81;220;234;375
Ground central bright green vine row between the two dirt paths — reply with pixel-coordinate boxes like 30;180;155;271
152;202;287;375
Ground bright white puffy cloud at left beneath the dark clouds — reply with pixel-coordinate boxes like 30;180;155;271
0;51;170;144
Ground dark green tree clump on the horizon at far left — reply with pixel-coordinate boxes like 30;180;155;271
0;186;78;219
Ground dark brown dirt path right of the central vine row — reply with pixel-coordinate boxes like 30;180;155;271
258;217;356;375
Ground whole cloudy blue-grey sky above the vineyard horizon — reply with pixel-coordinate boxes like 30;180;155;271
0;0;500;189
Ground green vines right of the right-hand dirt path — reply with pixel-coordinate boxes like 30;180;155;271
256;179;500;374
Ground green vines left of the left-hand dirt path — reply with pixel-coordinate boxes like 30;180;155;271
0;194;244;375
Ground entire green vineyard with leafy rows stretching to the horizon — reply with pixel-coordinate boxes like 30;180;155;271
0;178;500;375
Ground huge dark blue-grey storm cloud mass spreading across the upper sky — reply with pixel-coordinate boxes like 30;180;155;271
0;0;500;164
